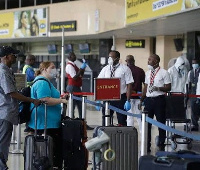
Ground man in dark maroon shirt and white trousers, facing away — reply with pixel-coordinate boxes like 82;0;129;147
126;55;145;133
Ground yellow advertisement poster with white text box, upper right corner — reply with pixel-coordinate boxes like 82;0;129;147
126;0;200;24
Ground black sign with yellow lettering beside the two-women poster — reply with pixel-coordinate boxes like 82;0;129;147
50;21;76;32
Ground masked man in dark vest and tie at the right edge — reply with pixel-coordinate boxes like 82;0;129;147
188;59;200;131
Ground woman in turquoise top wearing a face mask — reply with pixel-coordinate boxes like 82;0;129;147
28;61;67;169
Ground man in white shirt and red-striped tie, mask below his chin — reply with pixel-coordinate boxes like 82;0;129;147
140;54;171;152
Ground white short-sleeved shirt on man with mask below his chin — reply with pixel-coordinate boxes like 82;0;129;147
145;67;171;97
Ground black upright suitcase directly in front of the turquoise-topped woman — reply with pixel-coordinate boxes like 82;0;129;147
62;118;89;170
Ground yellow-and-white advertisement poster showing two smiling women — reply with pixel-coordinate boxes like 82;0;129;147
0;8;47;39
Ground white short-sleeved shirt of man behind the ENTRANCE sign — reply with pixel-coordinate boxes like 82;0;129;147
98;64;134;94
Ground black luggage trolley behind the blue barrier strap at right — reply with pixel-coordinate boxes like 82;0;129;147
166;92;192;150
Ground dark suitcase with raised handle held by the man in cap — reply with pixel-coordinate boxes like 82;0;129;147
24;104;53;170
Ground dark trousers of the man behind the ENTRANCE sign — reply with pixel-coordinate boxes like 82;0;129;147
102;93;127;126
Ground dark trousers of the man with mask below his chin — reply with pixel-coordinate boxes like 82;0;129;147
144;95;166;149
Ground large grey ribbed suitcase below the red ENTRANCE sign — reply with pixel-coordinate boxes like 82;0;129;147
93;126;138;170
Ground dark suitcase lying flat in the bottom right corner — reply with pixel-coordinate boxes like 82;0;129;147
139;155;200;170
